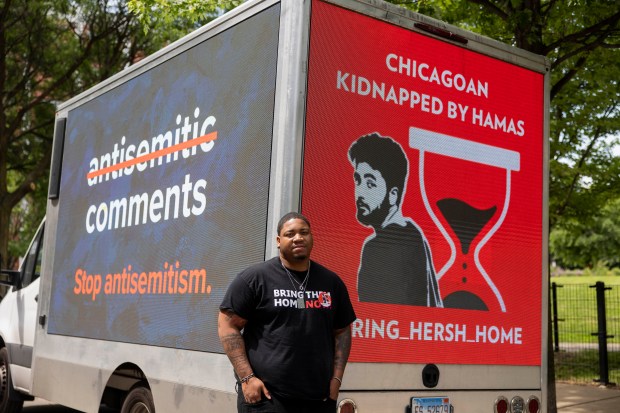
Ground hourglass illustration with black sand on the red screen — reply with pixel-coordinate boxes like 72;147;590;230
409;127;520;312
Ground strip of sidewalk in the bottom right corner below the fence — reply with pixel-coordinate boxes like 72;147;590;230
555;383;620;413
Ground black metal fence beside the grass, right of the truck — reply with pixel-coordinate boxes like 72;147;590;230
551;282;620;385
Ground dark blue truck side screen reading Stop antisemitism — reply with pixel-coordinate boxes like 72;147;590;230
48;6;280;352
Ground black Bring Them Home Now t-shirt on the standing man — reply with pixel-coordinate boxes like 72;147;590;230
220;257;355;400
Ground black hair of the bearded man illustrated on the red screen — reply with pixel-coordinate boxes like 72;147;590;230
349;132;409;205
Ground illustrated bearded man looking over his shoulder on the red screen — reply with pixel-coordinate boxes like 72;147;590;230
349;133;443;307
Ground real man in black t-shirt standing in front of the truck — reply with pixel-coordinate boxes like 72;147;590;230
218;212;355;413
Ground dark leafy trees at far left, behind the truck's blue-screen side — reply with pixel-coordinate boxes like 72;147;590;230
0;0;188;267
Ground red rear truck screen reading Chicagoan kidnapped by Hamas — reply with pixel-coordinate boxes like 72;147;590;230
302;1;544;365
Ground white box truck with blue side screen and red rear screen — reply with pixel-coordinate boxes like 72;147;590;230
0;0;549;413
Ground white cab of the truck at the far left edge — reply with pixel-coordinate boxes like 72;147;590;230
0;220;45;412
